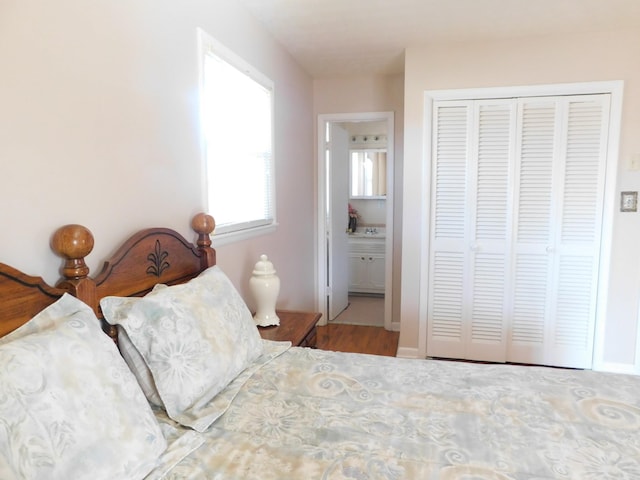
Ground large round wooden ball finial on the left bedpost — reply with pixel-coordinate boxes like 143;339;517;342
51;224;93;279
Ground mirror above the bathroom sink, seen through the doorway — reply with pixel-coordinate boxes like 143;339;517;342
349;149;387;199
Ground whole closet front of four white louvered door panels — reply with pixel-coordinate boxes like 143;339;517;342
427;94;610;368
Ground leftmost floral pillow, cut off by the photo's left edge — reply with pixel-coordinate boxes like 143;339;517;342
0;294;167;480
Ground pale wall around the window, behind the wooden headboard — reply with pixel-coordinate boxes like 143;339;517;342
0;0;315;309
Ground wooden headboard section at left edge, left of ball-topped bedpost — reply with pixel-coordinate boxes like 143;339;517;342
0;263;65;337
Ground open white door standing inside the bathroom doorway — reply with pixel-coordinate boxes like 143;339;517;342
326;122;349;320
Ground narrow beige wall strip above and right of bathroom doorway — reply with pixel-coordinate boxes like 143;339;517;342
313;75;404;322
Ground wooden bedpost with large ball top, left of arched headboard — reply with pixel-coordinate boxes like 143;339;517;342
51;225;98;314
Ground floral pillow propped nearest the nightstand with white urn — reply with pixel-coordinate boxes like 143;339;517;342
100;266;263;432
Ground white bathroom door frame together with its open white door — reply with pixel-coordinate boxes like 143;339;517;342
317;112;394;330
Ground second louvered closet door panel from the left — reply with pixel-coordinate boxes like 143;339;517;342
466;100;516;361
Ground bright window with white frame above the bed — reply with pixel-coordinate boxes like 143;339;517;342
199;30;275;238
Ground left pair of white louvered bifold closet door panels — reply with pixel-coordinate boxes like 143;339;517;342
427;100;516;361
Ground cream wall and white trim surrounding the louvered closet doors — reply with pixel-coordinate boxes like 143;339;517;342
400;31;640;371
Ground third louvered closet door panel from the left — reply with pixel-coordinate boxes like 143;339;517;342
502;98;560;363
